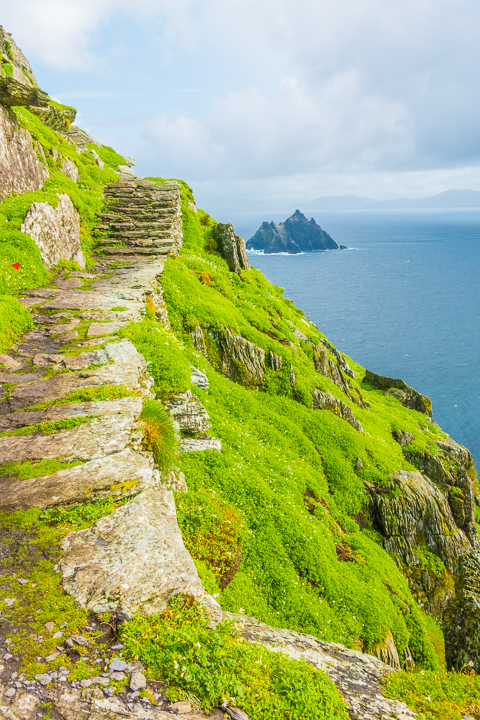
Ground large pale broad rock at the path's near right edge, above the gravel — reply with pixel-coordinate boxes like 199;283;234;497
59;486;218;618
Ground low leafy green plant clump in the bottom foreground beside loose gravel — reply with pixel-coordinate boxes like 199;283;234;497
121;597;348;720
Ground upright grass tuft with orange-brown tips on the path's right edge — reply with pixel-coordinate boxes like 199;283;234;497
140;399;178;472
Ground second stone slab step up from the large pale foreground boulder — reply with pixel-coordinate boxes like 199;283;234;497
0;412;136;462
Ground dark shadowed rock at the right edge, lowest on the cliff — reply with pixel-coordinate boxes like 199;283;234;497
443;551;480;673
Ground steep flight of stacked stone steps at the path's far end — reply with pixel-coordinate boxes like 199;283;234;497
95;179;182;257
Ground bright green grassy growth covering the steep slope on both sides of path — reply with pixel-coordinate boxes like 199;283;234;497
0;109;474;718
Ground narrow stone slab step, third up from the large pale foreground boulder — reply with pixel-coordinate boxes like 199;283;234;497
0;397;143;432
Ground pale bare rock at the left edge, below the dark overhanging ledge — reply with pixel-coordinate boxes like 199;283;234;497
0;99;49;200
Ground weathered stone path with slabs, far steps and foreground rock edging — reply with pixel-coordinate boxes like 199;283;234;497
0;181;414;720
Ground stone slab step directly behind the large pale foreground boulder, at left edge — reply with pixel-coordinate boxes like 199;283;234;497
0;448;156;512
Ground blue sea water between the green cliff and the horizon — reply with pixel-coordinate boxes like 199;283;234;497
246;211;480;464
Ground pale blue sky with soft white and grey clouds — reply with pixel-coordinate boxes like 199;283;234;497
0;0;480;220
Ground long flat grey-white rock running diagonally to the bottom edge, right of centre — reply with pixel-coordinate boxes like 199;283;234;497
220;613;416;720
